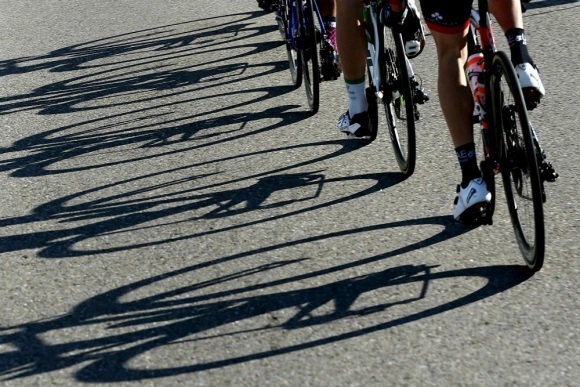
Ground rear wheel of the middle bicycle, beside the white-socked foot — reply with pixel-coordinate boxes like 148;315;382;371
383;28;417;177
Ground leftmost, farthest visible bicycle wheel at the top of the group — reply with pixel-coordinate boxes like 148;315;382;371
276;0;302;89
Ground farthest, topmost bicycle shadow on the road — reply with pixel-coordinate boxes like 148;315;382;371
0;12;279;80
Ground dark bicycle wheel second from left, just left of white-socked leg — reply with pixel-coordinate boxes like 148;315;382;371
300;0;321;114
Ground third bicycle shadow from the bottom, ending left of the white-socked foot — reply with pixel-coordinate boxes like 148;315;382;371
0;81;308;177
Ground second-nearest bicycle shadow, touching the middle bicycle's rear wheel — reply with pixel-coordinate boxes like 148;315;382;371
0;162;403;258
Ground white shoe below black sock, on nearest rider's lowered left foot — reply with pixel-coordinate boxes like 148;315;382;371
453;177;491;223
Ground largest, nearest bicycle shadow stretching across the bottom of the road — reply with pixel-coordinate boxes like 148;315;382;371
0;216;530;383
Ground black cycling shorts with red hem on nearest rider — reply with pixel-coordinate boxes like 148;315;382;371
420;0;473;34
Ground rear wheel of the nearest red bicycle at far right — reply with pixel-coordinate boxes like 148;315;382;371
490;52;545;271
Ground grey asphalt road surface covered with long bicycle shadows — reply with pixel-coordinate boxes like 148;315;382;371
0;0;580;386
